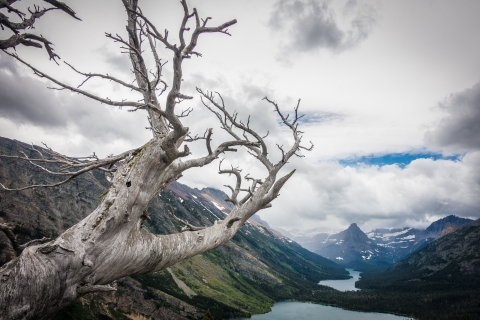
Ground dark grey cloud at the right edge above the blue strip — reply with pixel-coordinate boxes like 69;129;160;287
425;82;480;152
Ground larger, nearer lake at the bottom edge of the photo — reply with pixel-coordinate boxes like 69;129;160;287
232;301;406;320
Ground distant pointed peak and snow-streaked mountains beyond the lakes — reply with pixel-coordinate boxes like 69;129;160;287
293;215;472;270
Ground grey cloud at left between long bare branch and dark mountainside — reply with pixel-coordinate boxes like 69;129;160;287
0;55;146;147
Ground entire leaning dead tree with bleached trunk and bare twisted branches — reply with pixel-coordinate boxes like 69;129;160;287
0;0;313;319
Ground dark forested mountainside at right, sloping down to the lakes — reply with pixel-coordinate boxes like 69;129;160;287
350;225;480;319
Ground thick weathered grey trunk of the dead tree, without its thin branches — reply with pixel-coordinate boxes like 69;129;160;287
0;138;232;319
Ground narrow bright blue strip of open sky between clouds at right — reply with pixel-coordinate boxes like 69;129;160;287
338;152;461;168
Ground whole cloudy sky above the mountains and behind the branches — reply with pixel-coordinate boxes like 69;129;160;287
0;0;480;232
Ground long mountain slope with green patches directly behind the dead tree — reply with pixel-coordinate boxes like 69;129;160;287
0;137;348;319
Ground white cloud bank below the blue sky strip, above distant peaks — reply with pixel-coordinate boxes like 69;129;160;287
261;152;480;231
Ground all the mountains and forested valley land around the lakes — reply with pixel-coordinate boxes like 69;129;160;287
0;138;480;320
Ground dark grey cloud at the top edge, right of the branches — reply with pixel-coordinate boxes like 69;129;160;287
269;0;376;55
